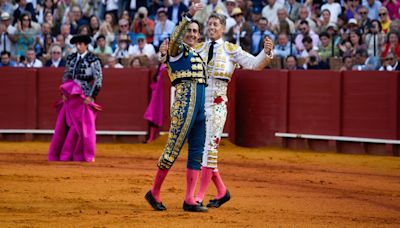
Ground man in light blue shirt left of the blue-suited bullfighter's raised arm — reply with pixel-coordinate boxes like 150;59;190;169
153;8;175;48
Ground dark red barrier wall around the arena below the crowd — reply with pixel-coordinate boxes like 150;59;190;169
0;68;400;155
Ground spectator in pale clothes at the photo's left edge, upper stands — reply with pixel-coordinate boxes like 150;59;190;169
0;12;17;55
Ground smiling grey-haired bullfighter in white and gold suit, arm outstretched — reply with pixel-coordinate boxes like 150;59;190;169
196;13;273;207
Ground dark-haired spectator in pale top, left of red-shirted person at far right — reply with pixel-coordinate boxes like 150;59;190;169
364;20;386;56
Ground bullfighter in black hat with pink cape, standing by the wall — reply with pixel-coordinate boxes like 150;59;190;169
48;35;103;162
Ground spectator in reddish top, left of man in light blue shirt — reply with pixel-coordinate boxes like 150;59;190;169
131;6;154;44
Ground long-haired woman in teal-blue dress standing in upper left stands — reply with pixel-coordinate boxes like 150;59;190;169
16;13;36;58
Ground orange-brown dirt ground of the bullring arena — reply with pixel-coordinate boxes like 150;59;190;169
0;136;400;227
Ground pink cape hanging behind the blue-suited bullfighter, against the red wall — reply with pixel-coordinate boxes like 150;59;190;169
144;64;167;127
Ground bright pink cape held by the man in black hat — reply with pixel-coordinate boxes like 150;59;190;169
48;80;101;162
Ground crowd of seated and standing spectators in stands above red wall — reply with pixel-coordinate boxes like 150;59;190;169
0;0;400;71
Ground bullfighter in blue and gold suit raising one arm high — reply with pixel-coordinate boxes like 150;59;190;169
145;1;207;212
